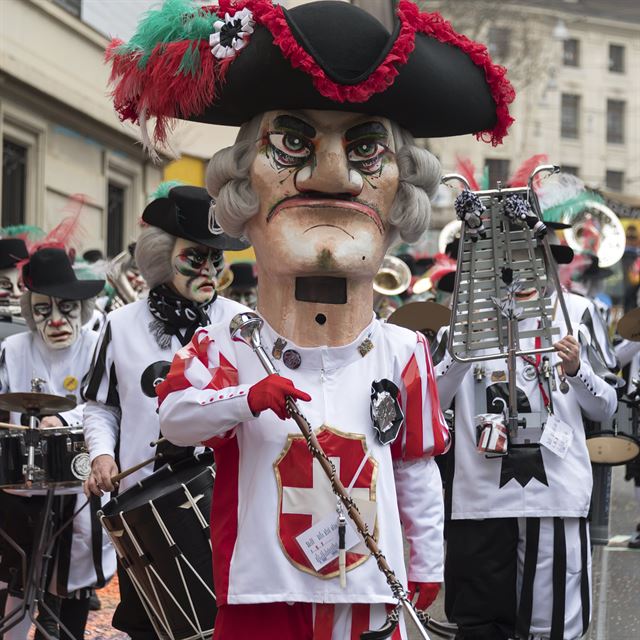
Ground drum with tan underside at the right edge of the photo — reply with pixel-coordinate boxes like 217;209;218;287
584;400;640;465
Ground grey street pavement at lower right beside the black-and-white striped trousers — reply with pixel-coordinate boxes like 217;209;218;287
408;467;640;640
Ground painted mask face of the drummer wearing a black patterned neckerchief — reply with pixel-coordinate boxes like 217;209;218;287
171;238;222;304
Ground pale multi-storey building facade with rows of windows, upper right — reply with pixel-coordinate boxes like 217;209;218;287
424;0;640;208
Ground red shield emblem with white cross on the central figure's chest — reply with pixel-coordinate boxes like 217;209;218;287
273;426;378;578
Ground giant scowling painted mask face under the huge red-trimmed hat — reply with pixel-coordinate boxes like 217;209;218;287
247;111;398;279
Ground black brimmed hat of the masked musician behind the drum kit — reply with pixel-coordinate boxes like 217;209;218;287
22;247;104;300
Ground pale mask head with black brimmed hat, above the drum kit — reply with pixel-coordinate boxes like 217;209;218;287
21;248;104;349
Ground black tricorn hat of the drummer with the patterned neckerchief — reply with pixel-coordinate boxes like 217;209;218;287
142;185;249;251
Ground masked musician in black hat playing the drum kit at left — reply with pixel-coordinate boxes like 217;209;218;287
0;248;115;640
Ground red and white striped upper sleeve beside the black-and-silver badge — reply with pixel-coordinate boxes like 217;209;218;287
391;334;450;461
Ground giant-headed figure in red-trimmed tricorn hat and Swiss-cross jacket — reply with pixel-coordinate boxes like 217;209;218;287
104;0;513;639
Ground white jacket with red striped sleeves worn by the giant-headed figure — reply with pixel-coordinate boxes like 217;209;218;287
159;320;449;604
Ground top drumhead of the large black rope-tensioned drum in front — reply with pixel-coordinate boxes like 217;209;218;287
102;451;213;519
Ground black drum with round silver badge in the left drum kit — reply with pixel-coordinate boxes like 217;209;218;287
40;427;91;487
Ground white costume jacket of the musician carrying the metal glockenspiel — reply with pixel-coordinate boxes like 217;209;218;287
436;295;617;520
